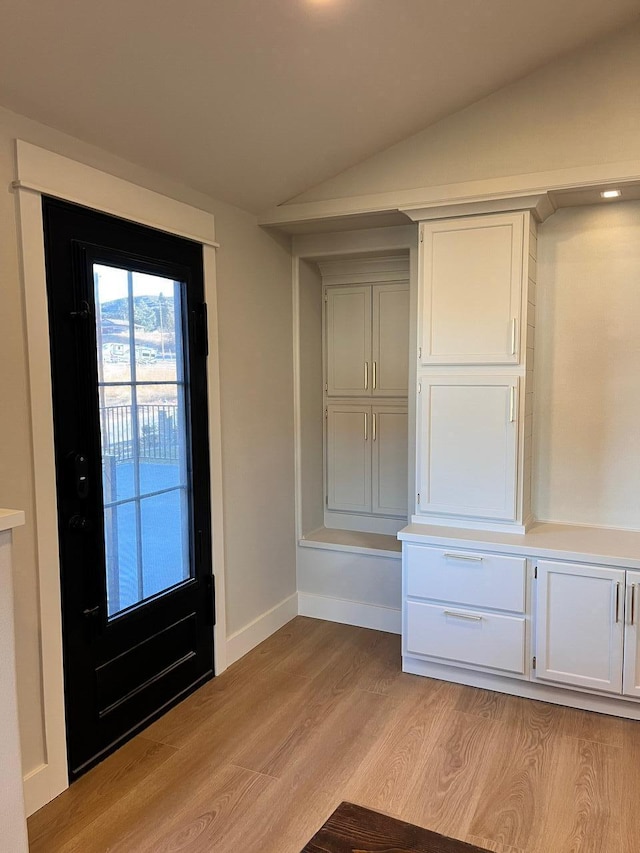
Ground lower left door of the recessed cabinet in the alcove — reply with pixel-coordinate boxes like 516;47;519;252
327;403;372;512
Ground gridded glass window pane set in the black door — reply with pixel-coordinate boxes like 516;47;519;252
93;264;191;617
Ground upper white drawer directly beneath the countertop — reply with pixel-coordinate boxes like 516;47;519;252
404;545;527;613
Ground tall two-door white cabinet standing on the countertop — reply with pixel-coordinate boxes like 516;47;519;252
413;211;536;531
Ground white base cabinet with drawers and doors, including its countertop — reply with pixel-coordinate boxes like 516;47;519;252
399;524;640;719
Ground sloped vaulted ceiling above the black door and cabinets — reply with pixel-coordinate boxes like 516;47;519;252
0;0;639;211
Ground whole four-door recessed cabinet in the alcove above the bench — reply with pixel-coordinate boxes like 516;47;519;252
319;257;409;533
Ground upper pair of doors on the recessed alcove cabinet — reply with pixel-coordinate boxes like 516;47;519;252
326;283;409;397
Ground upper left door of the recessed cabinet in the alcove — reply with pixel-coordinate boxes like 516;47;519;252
326;285;372;397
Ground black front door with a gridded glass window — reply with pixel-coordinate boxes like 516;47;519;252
43;198;214;779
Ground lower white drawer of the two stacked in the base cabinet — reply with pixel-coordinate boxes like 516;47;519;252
405;601;525;674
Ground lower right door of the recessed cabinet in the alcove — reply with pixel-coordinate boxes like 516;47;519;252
371;406;408;516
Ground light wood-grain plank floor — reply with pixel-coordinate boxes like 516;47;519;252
27;617;640;853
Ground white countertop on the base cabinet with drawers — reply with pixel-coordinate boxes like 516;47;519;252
398;522;640;569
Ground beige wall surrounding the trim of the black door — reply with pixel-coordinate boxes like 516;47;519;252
0;109;296;773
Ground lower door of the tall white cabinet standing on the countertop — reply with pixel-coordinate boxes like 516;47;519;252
417;376;518;521
